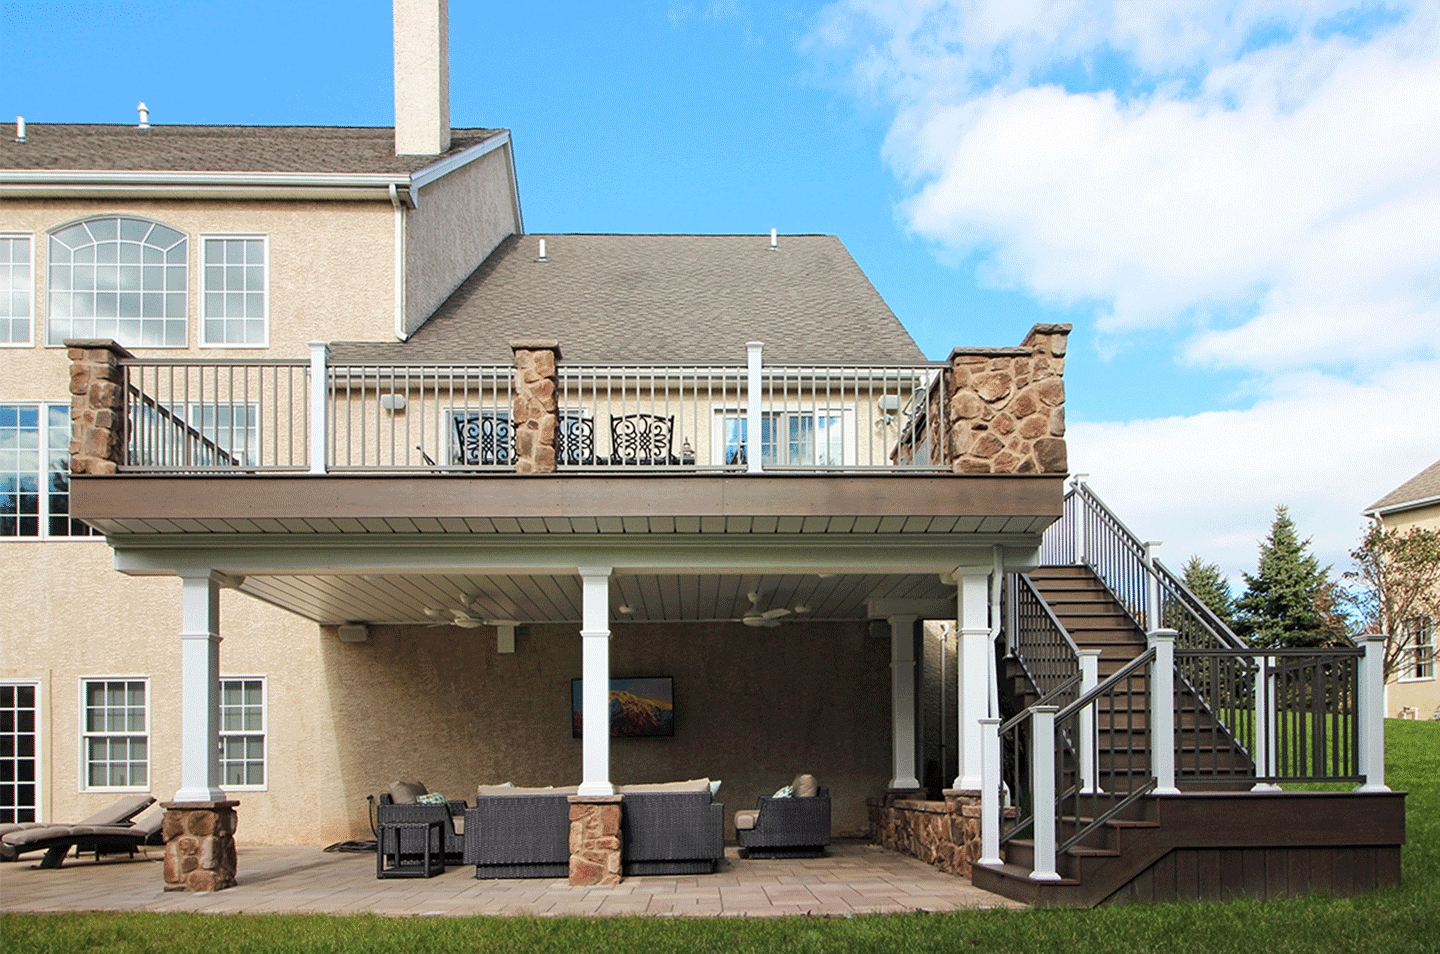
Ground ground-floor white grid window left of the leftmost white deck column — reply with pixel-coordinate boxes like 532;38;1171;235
81;679;150;791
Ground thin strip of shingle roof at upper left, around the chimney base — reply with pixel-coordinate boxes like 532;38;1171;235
0;122;504;174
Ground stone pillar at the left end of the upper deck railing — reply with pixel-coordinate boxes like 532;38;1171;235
65;339;134;474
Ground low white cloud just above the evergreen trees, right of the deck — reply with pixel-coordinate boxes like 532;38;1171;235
1067;360;1440;581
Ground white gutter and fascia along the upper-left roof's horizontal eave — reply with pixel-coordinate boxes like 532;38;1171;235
0;169;415;202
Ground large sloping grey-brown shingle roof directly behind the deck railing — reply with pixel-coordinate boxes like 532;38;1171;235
331;235;926;365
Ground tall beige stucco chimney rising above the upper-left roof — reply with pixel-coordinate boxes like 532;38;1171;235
395;0;449;156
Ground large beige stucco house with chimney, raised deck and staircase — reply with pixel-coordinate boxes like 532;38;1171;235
0;0;1403;904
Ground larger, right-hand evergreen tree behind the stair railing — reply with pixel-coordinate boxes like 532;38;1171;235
1234;507;1348;647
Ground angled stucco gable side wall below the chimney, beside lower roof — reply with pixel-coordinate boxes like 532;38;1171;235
405;146;520;334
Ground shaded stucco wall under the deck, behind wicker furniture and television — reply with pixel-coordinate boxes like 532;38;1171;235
320;623;890;839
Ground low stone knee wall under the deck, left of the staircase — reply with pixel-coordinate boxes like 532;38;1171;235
870;791;981;878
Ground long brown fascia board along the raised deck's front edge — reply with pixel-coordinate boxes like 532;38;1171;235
71;473;1064;522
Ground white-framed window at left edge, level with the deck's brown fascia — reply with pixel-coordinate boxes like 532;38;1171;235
0;404;94;539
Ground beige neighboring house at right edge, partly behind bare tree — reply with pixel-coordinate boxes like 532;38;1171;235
1365;461;1440;719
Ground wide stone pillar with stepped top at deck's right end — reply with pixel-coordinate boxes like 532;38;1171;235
948;324;1070;474
